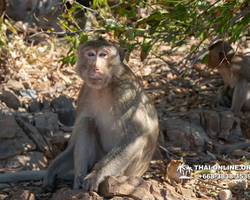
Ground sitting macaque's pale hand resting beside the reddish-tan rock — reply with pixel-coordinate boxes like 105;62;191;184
80;171;104;191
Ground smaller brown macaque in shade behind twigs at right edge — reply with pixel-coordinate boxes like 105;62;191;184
207;41;250;115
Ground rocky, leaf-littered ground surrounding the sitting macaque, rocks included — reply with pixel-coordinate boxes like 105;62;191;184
0;27;250;200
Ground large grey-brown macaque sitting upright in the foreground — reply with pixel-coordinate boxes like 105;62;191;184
43;38;159;191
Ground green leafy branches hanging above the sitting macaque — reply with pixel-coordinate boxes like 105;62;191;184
0;0;250;68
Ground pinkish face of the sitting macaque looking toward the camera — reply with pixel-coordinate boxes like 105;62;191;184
76;46;121;89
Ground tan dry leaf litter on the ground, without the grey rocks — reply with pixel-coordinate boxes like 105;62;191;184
0;28;250;200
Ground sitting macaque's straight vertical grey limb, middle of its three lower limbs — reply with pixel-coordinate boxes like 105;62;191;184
74;118;97;189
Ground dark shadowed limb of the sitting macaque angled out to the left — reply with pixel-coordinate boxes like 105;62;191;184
43;145;74;191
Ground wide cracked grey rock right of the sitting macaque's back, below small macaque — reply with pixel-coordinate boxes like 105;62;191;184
160;110;242;153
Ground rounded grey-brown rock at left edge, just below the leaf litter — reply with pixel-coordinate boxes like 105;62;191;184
0;91;22;110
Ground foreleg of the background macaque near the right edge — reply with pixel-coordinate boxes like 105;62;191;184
231;78;248;115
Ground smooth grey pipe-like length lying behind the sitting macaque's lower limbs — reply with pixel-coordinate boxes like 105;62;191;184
0;170;74;183
